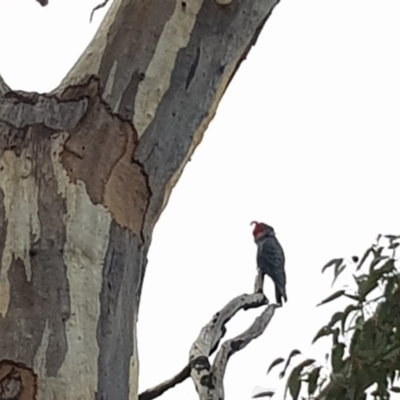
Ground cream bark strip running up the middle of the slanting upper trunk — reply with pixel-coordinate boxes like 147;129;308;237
133;0;204;137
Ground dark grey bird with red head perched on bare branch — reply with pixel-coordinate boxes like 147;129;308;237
250;221;287;305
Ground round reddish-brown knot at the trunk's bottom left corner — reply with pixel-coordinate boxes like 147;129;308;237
0;360;37;400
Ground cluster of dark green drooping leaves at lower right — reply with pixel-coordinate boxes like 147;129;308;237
255;235;400;400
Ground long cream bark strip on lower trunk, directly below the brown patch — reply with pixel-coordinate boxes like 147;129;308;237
39;134;111;399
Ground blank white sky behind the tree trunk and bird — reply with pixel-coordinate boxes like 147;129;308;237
0;0;400;400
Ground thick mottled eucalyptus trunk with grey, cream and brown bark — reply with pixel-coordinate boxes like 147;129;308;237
0;0;278;400
